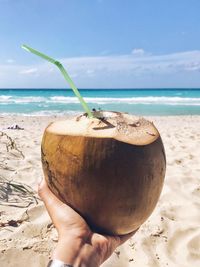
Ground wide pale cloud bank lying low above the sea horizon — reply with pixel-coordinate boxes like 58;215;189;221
0;49;200;88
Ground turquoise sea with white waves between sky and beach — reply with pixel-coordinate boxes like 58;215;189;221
0;89;200;116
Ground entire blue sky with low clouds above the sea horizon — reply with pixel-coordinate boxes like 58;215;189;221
0;0;200;88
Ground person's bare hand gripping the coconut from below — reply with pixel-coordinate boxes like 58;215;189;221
38;179;137;267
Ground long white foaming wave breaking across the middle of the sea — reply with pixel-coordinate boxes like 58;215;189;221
0;95;200;106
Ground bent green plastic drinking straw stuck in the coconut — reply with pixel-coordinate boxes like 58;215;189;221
21;45;94;118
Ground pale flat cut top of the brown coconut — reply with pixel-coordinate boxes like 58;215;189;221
46;111;159;145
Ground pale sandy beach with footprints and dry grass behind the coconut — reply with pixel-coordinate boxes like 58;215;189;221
0;116;200;267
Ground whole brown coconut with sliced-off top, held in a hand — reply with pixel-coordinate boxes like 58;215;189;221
41;112;166;235
